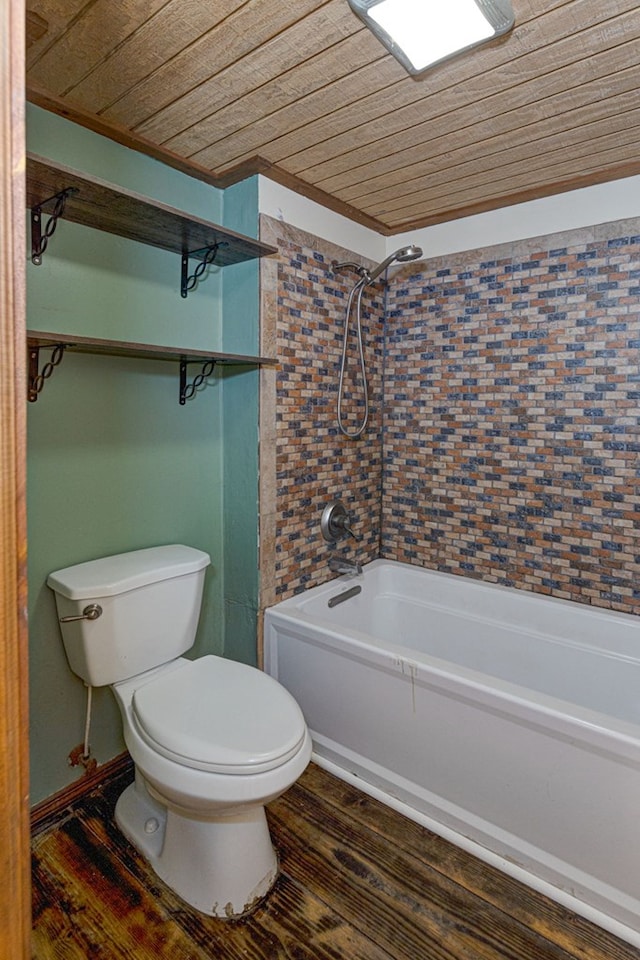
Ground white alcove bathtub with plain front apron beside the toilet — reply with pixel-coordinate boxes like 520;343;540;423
265;560;640;946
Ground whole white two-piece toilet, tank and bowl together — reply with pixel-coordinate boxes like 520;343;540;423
47;545;311;917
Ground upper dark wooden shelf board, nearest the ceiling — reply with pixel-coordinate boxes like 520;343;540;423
27;154;276;267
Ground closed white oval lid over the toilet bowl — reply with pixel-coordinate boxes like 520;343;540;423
132;656;306;774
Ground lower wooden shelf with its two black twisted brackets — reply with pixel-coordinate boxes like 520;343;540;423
27;330;278;405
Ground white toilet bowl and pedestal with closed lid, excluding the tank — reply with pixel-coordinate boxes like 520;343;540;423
112;656;311;917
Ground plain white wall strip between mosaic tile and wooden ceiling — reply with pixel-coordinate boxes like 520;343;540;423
259;176;640;260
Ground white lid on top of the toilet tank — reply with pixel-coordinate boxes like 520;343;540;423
47;544;211;600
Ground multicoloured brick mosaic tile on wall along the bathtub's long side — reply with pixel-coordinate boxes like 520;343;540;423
382;236;640;613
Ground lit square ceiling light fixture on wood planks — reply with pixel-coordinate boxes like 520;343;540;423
349;0;514;74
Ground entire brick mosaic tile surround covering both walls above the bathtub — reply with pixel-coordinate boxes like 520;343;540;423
262;218;640;613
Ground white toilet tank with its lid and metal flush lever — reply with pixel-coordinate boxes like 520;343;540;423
47;544;210;687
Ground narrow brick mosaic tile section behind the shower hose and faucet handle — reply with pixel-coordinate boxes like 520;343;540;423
275;228;383;600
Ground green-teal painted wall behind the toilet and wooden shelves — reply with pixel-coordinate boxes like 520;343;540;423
27;108;258;802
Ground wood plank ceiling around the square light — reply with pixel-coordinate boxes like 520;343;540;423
22;0;640;234
